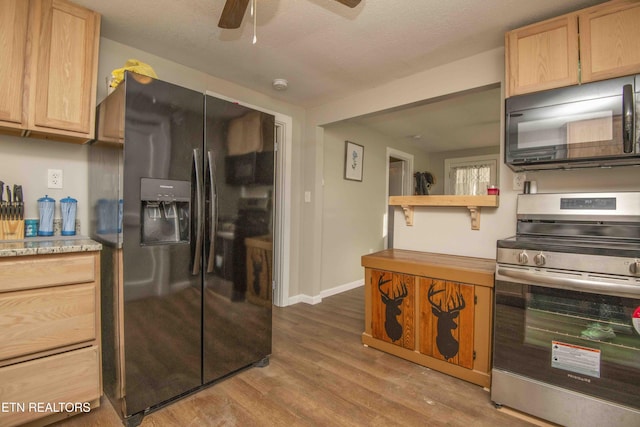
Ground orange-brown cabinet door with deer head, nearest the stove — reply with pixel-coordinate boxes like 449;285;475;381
418;277;475;369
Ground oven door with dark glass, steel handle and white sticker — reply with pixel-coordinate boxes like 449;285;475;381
493;265;640;410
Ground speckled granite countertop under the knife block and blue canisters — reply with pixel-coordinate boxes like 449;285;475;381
0;236;102;257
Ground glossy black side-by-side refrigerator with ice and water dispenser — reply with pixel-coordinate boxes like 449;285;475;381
89;72;275;425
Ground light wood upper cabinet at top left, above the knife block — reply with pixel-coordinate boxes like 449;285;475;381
0;0;100;143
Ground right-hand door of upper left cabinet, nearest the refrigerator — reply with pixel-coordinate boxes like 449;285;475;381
29;0;100;139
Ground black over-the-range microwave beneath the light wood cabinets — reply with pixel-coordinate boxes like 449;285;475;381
505;75;640;171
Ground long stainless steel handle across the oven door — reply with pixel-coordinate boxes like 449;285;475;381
496;267;640;298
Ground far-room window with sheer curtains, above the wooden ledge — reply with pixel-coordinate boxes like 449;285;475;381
444;154;498;196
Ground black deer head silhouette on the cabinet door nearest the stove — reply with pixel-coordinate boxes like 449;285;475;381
427;283;465;360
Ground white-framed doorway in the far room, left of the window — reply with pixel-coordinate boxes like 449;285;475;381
384;147;413;249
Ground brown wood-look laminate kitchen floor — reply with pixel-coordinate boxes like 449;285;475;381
50;287;544;427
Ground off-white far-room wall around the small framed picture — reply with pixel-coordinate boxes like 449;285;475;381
321;122;428;296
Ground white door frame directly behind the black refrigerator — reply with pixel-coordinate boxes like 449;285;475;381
205;90;293;307
